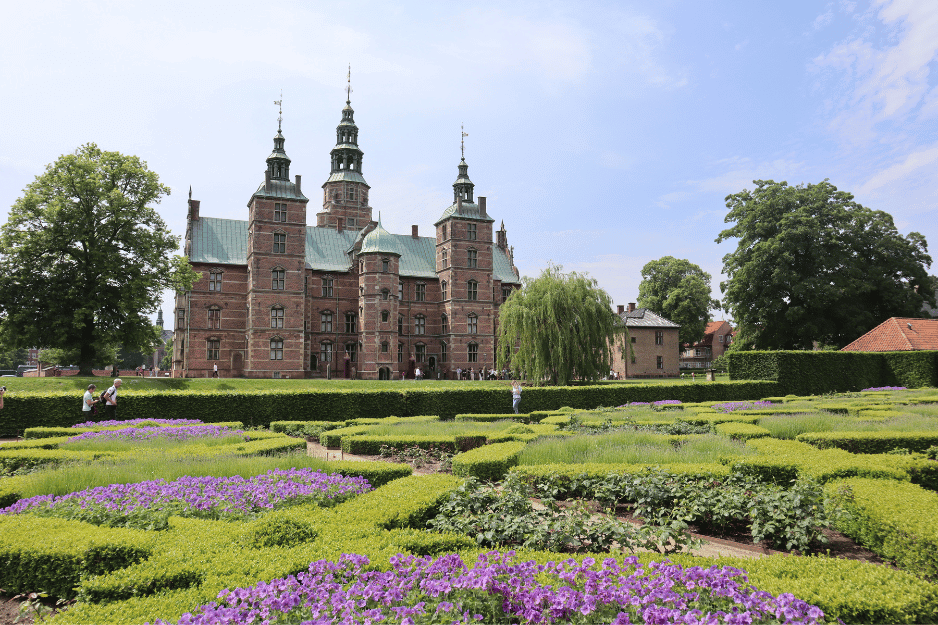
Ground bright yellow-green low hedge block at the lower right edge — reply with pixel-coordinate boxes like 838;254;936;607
825;478;938;582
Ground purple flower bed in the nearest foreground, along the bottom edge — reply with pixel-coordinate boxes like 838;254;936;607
157;551;824;625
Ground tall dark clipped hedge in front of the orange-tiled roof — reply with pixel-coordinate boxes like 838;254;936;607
727;351;938;395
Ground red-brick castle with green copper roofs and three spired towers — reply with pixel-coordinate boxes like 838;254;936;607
173;91;521;379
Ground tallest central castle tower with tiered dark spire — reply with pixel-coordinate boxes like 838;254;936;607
316;73;371;230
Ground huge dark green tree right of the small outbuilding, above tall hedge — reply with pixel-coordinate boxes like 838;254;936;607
716;180;934;349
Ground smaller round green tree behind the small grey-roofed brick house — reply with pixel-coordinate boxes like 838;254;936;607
638;256;720;349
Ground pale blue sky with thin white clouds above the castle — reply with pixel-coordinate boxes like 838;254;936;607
0;0;938;319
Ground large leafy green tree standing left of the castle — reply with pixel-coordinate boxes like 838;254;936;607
0;143;197;374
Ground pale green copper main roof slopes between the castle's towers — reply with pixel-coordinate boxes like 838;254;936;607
189;217;521;284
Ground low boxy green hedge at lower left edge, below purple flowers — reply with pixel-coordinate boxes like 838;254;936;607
0;515;153;598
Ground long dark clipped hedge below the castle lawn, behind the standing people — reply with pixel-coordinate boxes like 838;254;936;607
0;381;779;436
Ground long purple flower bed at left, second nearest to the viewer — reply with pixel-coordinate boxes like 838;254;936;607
0;469;371;529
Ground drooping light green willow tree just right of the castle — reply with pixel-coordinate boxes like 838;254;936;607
496;265;626;385
